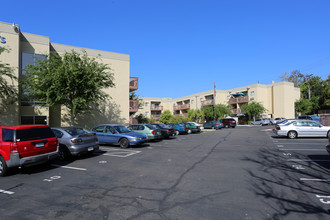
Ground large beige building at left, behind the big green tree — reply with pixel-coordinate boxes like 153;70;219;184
0;22;138;128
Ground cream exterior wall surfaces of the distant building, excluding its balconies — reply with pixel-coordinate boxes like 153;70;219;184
137;82;300;118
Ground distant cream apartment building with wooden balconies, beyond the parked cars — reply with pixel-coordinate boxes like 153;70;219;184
137;81;300;119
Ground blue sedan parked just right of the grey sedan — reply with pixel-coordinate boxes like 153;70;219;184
90;124;147;148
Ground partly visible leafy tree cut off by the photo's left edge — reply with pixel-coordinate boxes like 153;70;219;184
0;47;18;102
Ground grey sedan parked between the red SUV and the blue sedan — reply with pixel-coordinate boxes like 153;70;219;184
52;127;99;160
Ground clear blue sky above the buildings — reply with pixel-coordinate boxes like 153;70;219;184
0;0;330;98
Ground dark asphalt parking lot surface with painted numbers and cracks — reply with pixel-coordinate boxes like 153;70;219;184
0;126;330;219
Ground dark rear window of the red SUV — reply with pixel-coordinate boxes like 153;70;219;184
16;127;55;141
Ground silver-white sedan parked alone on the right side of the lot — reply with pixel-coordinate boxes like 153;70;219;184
274;120;330;139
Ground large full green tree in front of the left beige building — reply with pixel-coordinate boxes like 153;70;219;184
22;51;115;125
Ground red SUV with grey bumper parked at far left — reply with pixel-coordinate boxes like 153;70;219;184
0;125;58;176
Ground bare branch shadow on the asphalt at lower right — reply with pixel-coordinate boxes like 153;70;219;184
242;148;330;219
